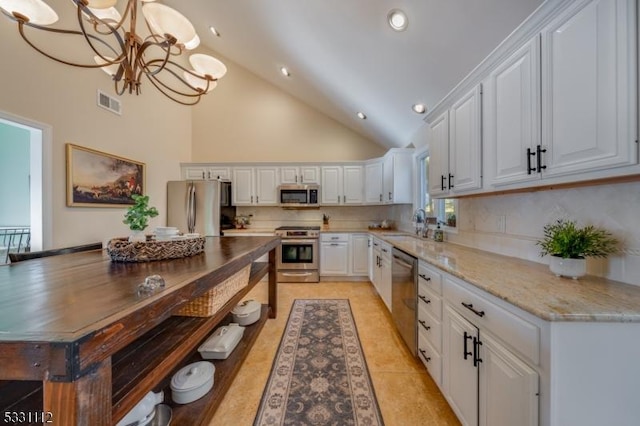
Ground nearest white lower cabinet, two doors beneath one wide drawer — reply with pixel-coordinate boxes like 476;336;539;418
442;278;539;426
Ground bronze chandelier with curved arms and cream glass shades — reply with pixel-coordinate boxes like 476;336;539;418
0;0;227;105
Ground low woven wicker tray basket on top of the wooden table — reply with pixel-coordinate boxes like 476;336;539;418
107;237;206;262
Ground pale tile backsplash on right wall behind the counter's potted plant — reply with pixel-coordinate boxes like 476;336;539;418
447;182;640;285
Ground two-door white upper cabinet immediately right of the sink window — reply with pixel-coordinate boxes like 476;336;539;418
429;85;482;196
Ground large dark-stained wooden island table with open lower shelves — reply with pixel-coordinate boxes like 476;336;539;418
0;237;280;426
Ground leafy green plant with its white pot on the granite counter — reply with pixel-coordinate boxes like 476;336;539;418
537;219;618;279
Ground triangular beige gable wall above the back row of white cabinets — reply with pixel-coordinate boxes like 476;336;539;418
193;53;386;162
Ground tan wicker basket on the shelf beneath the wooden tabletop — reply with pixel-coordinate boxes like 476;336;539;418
174;265;251;317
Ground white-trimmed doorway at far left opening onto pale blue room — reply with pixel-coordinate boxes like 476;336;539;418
0;111;52;263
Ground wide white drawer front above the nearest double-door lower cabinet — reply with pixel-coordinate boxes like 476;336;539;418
444;278;540;365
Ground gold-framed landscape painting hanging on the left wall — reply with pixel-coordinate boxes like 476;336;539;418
66;143;146;208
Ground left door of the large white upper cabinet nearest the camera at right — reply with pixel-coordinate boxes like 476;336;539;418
490;36;540;186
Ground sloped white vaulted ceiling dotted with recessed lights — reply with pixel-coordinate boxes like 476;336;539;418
164;0;542;148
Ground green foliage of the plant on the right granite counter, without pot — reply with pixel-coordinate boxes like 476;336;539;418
536;219;618;259
